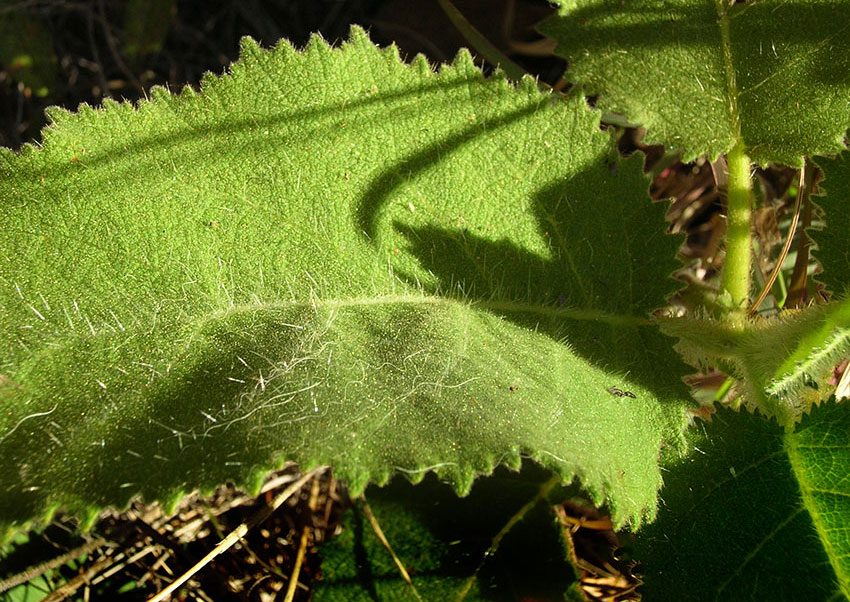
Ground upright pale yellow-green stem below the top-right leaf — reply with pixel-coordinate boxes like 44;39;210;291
721;142;752;310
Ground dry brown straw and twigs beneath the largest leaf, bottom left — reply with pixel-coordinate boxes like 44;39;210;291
0;465;348;601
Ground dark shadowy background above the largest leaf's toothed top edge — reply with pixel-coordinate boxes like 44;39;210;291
0;0;564;149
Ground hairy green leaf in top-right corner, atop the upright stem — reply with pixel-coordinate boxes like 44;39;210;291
541;0;850;165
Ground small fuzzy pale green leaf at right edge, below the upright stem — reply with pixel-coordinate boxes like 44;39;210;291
661;298;850;426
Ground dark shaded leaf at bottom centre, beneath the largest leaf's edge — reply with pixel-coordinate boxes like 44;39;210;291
313;465;574;602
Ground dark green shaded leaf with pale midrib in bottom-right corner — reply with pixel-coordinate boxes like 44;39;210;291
635;403;850;602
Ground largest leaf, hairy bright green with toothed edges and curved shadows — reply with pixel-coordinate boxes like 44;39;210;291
0;30;685;536
